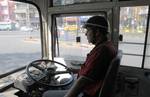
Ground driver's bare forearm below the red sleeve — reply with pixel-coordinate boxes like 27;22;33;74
64;76;94;97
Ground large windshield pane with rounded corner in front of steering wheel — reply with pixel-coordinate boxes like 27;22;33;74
0;0;41;74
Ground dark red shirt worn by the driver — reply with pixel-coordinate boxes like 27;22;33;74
78;41;117;97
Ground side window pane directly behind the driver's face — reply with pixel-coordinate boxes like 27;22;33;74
56;15;105;61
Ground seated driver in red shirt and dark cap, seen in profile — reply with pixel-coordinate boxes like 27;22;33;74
43;16;117;97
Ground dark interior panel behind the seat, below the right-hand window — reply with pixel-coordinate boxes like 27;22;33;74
115;66;150;97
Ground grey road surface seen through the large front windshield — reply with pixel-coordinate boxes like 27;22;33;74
0;31;41;74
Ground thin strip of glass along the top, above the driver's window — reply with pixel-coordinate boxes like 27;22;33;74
53;0;110;6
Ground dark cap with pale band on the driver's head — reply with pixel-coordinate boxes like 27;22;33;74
83;16;108;31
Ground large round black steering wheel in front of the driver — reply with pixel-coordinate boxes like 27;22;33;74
26;59;74;87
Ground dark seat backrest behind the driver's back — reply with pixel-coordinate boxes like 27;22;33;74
99;50;122;97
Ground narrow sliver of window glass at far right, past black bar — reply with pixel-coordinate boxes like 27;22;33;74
144;8;150;68
